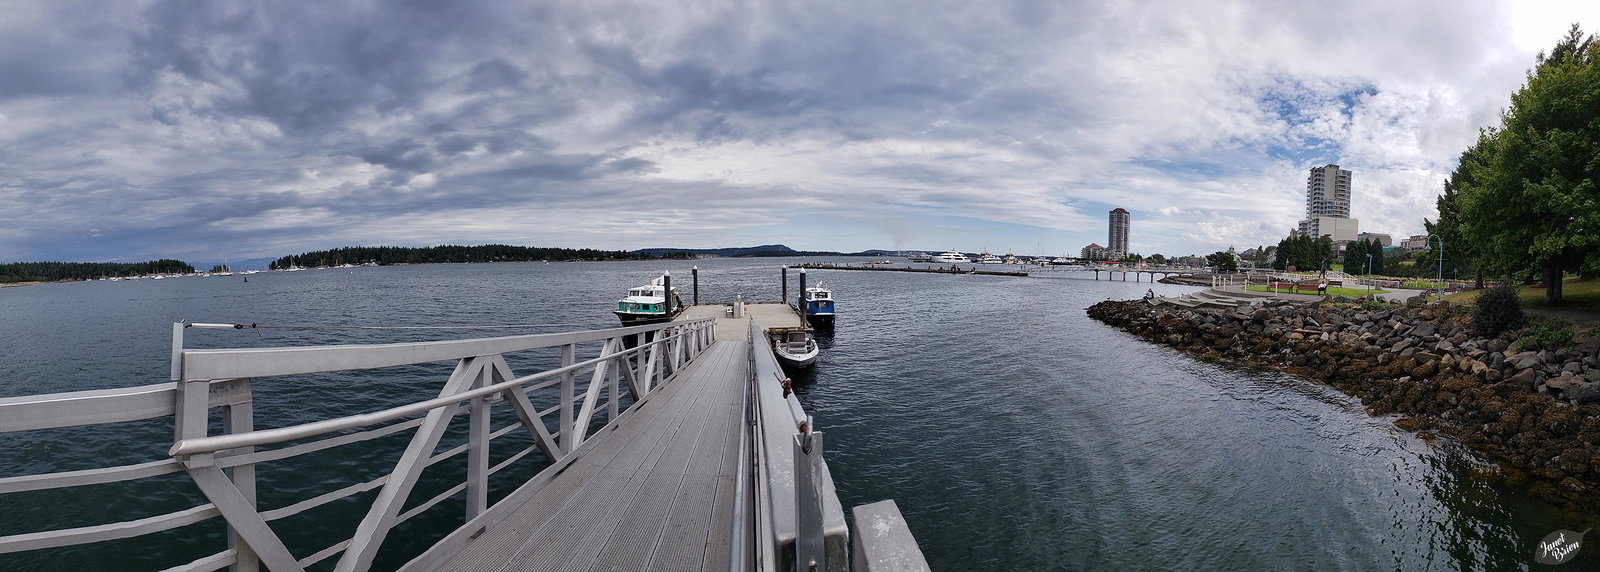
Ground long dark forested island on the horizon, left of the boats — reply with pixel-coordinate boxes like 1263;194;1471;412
269;244;693;270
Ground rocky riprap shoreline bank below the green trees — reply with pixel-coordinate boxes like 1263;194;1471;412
1088;300;1600;505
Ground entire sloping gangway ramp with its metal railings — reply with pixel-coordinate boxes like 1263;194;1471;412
0;307;926;570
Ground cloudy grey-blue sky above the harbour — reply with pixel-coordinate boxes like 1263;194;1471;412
0;0;1600;262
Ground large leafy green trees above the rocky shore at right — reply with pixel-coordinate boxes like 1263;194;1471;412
1424;24;1600;304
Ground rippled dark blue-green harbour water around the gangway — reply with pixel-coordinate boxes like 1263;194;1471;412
0;259;1600;570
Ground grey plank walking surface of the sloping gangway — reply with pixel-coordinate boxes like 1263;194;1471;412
442;341;749;570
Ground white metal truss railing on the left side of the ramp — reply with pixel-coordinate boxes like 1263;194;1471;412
0;320;715;572
